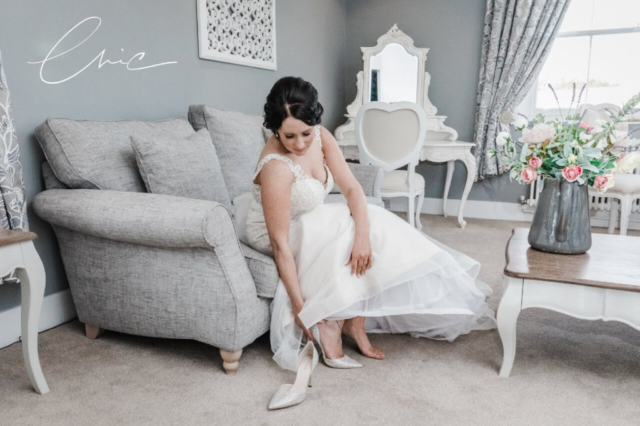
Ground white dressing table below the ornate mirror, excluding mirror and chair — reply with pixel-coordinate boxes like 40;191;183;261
338;139;477;228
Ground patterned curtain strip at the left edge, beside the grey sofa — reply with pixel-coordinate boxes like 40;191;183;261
0;48;29;231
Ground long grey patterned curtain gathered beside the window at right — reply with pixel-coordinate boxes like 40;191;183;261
474;0;570;180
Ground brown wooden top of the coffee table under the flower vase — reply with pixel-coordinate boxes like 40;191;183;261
504;228;640;292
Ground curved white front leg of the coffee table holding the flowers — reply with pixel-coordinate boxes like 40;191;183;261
498;277;523;377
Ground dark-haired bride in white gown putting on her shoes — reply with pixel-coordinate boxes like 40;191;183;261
246;77;495;406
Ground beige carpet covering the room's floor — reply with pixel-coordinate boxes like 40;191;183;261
0;215;640;426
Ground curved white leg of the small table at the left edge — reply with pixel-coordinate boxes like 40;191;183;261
16;241;49;395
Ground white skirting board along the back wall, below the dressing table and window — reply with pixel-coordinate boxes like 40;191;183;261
385;197;640;232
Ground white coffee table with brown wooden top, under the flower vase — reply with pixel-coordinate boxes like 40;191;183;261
497;228;640;377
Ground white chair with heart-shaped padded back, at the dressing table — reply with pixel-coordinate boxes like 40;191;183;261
355;102;427;229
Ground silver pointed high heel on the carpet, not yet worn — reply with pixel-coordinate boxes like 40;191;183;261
269;340;318;410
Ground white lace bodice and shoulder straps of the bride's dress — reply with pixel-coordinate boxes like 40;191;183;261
251;126;334;218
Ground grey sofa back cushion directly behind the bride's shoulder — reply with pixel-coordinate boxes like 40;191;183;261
189;105;268;200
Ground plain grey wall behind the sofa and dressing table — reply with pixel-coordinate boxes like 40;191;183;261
0;0;525;311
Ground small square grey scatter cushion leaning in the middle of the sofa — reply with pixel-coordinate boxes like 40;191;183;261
131;129;231;208
